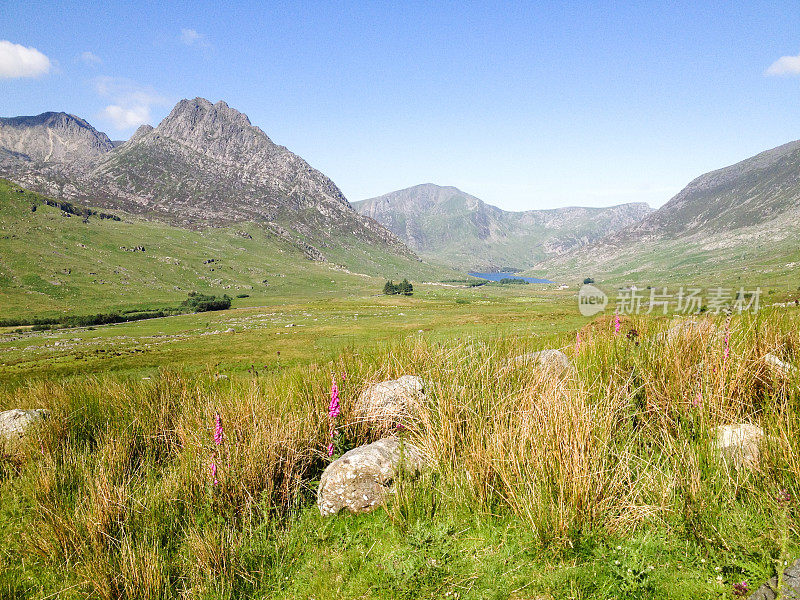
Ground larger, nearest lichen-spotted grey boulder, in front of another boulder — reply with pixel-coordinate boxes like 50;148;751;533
317;437;425;516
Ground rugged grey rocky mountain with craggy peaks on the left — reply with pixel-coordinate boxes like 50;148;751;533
0;98;418;260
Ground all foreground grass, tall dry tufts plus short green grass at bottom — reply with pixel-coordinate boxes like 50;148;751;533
0;315;800;599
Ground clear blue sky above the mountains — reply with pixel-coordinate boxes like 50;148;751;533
0;0;800;210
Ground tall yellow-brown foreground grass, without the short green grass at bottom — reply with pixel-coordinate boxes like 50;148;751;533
0;315;800;599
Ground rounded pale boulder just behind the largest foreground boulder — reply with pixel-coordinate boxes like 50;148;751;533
353;375;425;431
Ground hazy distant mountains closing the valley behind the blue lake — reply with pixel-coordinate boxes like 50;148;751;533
353;184;651;271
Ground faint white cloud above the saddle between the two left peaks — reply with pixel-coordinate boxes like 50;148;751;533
95;77;170;131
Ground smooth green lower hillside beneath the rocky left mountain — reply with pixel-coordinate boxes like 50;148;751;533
0;179;453;318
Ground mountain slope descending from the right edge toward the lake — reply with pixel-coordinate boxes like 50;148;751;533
530;141;800;286
